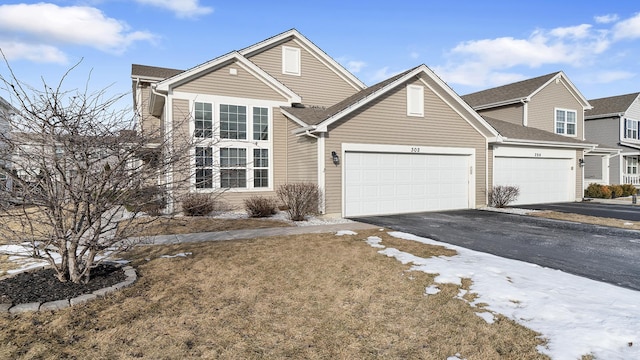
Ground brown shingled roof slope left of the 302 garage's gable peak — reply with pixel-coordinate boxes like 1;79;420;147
282;66;419;125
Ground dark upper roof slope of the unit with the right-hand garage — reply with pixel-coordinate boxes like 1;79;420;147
462;71;560;108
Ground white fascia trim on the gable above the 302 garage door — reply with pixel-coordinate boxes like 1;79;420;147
281;64;498;137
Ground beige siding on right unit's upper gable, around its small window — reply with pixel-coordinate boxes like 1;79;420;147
527;81;584;139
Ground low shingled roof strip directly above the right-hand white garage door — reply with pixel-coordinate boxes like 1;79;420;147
482;116;597;148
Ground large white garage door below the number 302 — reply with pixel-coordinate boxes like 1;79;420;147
344;152;471;216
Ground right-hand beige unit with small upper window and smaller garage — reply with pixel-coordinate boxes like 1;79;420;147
462;71;597;204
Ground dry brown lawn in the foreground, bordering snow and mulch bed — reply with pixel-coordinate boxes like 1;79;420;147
0;230;546;359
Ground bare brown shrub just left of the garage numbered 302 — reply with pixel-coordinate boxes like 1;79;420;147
276;183;320;221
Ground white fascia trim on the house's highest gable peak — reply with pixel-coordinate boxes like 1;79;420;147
239;29;367;90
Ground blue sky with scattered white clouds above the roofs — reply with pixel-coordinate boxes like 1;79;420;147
0;0;640;109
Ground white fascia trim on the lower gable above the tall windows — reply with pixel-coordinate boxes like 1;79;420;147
156;51;302;103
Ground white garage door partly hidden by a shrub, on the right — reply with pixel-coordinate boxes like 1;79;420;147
493;157;576;205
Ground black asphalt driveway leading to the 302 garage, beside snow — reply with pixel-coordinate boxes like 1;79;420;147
353;210;640;290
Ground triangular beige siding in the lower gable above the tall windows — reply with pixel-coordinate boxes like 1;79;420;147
174;62;285;101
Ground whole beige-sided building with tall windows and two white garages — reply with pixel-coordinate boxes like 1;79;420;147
131;29;595;217
